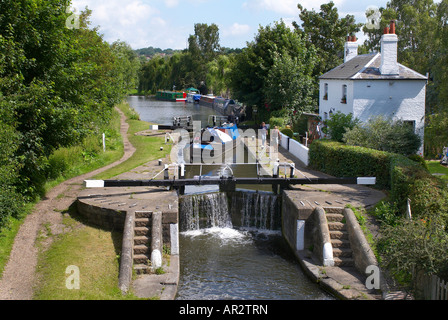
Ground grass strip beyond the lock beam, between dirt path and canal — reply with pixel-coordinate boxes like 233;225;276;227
93;103;171;180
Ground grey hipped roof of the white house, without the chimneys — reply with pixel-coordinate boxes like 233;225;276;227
320;53;428;80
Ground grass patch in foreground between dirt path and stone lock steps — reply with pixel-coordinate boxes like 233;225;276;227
34;215;137;300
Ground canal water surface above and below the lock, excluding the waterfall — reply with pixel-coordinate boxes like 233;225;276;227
128;97;333;300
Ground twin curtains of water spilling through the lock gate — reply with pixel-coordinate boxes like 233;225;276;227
179;191;281;231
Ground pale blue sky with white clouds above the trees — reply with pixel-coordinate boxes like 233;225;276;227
72;0;387;49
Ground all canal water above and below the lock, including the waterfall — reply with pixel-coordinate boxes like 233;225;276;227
128;97;332;300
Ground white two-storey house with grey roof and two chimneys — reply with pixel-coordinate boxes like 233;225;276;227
319;22;427;154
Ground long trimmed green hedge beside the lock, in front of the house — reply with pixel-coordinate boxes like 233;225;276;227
309;140;434;212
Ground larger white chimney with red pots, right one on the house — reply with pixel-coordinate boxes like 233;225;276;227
380;21;399;75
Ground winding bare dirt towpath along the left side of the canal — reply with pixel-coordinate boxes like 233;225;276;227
0;108;135;300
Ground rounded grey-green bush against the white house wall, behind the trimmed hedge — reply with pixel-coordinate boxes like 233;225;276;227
343;116;421;156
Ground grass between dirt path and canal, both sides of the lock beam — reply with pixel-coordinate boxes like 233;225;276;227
35;104;170;300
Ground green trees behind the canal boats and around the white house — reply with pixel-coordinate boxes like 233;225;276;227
138;0;448;154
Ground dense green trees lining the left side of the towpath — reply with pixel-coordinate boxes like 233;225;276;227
0;0;140;227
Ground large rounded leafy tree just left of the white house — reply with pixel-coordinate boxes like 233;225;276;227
229;21;317;119
